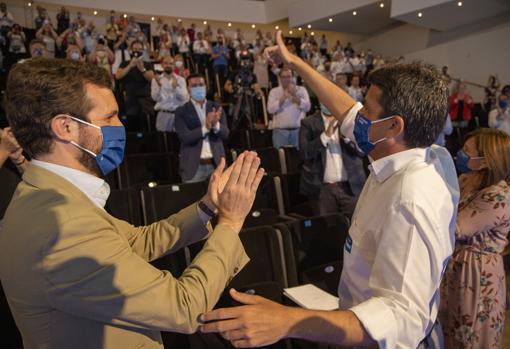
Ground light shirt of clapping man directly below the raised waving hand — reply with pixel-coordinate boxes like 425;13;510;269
267;86;311;129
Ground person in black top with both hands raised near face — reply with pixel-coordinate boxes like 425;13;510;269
115;41;154;131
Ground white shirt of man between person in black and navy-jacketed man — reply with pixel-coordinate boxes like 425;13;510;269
151;73;189;111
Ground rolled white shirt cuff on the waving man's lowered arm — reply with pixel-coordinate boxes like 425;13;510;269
349;297;397;348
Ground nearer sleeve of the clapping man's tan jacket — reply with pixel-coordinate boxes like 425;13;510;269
41;209;248;333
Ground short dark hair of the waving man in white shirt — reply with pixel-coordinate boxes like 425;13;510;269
368;62;448;148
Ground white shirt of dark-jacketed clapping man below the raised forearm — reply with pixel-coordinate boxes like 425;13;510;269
321;113;347;183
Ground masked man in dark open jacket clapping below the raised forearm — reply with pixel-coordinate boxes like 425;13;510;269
299;103;366;219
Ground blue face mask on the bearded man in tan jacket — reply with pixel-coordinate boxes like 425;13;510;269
70;116;126;176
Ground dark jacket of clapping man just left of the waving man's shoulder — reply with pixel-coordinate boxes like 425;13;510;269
299;112;366;198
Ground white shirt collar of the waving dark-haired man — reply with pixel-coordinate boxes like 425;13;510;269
368;148;430;183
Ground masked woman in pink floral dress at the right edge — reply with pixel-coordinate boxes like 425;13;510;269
440;128;510;349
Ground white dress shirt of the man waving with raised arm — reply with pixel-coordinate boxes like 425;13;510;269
338;103;459;349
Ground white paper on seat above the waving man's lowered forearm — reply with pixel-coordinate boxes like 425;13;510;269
283;284;339;310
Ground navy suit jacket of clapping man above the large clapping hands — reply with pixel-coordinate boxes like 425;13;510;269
175;101;229;181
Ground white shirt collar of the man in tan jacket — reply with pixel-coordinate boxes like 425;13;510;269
31;159;110;208
